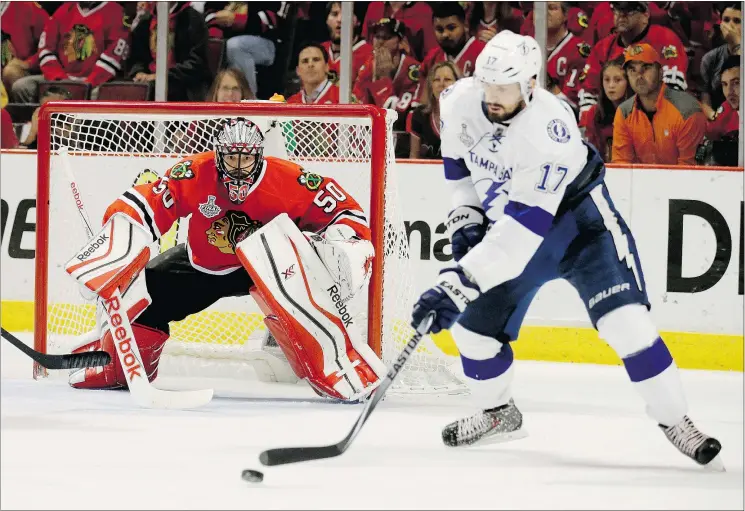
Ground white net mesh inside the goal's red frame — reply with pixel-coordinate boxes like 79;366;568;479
40;105;464;393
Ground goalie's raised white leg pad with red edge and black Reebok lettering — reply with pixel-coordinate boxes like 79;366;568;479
236;214;384;400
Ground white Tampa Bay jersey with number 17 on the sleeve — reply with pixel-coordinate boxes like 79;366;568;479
440;78;588;291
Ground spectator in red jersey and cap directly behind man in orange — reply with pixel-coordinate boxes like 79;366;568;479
578;2;688;111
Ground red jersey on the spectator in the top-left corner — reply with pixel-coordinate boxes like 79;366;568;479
0;2;49;69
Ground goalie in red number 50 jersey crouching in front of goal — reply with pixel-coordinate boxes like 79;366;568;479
61;118;386;400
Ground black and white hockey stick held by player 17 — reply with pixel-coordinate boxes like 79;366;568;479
259;313;434;466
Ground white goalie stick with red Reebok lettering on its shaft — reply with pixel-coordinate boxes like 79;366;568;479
59;147;214;410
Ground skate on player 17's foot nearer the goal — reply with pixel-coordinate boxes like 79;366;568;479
442;399;528;447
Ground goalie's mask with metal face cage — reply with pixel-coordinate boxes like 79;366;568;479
213;117;264;204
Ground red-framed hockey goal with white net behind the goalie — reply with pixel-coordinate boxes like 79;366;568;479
34;101;467;394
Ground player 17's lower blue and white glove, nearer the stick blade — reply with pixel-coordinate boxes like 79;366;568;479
411;266;481;334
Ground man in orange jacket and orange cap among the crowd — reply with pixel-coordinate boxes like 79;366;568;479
612;43;706;165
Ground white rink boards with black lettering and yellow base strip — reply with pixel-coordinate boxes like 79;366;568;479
0;152;743;371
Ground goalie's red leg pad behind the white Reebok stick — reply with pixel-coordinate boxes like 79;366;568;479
69;323;168;389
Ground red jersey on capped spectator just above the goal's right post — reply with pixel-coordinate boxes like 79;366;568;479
352;53;419;129
